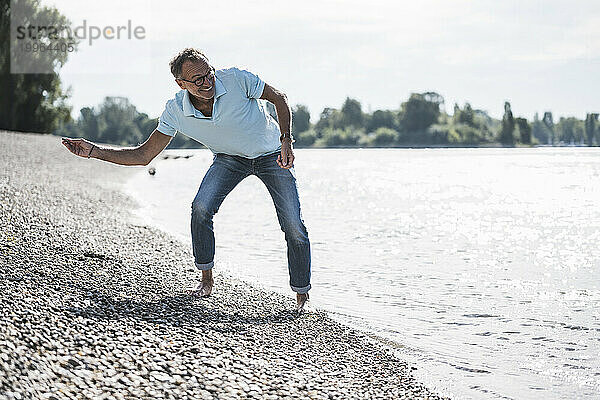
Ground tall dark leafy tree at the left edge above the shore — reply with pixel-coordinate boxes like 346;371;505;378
0;0;76;133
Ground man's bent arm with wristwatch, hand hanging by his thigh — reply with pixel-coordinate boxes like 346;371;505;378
260;83;294;169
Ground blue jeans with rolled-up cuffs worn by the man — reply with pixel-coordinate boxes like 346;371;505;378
191;151;311;293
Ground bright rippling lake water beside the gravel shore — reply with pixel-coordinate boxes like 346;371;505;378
128;148;600;399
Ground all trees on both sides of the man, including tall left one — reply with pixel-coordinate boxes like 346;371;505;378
0;0;600;148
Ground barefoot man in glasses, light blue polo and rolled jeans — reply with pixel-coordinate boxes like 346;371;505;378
63;48;311;312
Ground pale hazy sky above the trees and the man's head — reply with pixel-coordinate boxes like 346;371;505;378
42;0;600;122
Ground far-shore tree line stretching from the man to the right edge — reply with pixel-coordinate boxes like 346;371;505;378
292;92;600;147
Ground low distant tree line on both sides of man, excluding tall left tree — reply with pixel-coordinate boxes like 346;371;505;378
55;92;600;148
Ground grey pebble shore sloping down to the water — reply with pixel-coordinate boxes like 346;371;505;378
0;132;440;399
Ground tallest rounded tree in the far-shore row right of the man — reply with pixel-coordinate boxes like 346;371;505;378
399;92;444;143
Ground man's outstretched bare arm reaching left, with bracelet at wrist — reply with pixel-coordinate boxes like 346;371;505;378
63;129;173;165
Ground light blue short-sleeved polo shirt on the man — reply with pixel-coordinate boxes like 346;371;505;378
156;68;281;158
